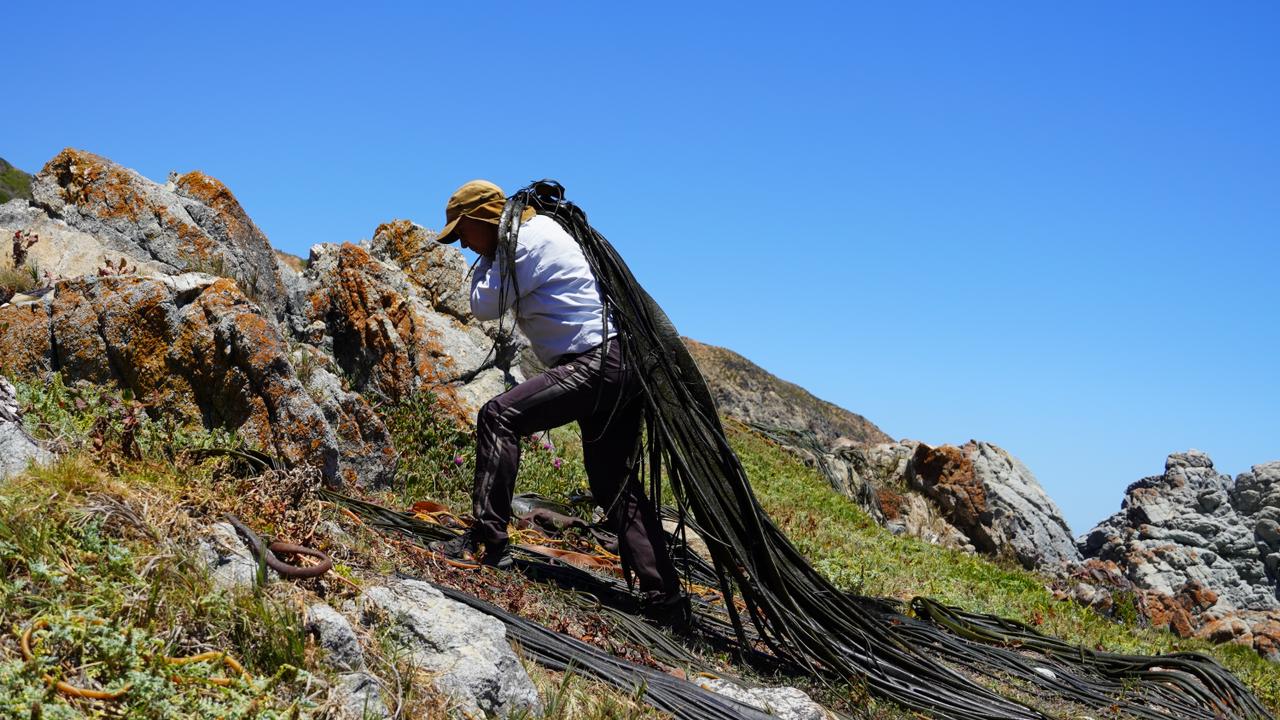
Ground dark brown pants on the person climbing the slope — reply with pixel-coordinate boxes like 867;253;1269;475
471;340;678;594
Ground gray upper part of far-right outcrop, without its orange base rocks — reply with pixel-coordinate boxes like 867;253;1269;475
1079;450;1280;615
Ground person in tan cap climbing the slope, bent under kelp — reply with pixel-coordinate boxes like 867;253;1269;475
433;181;687;624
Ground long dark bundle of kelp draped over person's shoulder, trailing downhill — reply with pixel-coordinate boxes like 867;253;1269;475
488;181;1267;720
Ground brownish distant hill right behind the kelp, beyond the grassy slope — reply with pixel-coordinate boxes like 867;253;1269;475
684;337;893;447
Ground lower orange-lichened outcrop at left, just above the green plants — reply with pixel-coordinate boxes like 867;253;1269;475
0;274;394;483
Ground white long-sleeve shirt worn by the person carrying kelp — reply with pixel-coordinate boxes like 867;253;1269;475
471;210;617;365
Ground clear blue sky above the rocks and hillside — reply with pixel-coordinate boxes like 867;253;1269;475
0;1;1280;533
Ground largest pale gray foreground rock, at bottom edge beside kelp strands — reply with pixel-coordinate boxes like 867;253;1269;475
358;580;541;717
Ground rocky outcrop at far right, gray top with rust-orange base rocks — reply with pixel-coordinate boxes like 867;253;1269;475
1073;450;1280;660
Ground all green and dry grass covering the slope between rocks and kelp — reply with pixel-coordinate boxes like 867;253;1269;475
0;382;1280;719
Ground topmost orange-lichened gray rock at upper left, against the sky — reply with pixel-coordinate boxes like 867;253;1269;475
28;147;287;316
